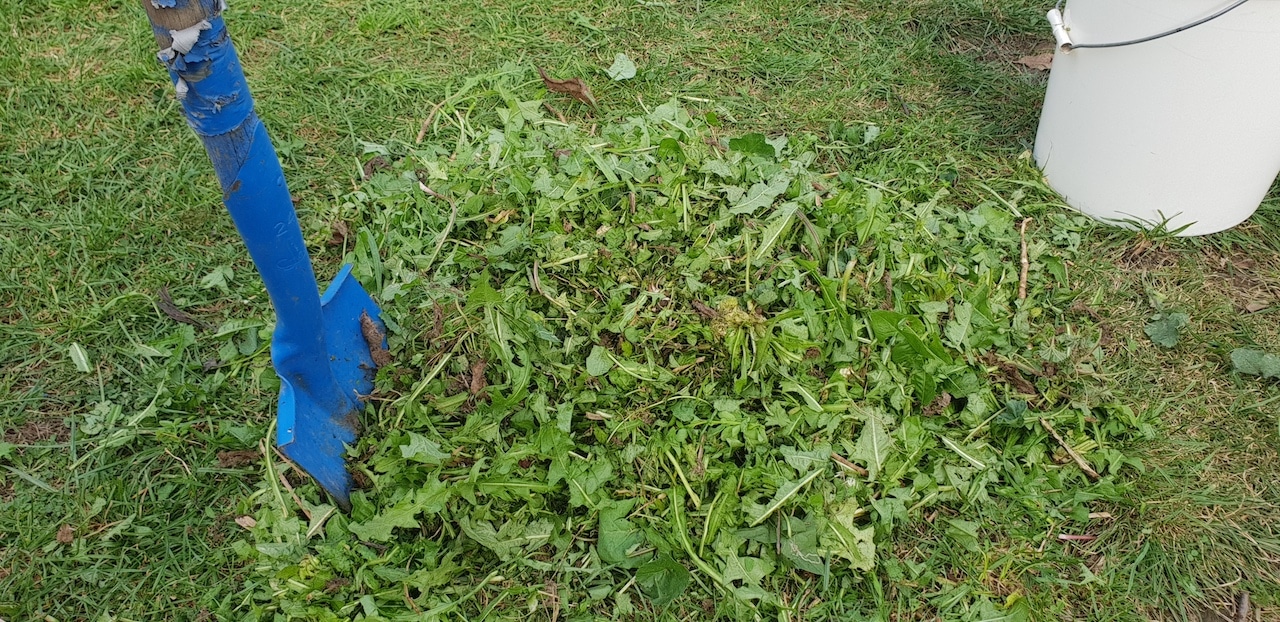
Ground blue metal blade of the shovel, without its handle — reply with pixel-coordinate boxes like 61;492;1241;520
276;265;387;509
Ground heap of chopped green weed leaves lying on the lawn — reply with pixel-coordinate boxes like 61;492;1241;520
237;71;1151;619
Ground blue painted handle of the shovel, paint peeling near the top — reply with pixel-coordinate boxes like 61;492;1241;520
145;0;353;412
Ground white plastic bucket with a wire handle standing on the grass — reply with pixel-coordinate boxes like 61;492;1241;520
1036;0;1280;235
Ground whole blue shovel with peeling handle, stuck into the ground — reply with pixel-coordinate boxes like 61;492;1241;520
142;0;385;509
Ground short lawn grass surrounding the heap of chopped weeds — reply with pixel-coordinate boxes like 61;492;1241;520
0;0;1280;619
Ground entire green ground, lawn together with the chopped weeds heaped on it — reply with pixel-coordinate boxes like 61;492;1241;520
0;0;1280;621
